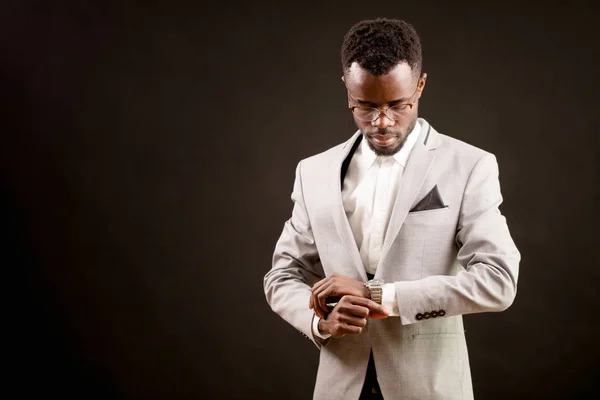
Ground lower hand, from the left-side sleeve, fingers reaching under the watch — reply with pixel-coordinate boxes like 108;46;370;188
319;295;390;339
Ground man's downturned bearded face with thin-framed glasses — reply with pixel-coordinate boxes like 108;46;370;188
343;62;427;155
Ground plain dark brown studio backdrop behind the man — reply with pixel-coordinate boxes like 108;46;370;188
0;1;600;399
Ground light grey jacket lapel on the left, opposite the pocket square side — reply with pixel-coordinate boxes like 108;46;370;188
330;131;367;281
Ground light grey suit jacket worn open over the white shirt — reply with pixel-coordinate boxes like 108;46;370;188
264;119;520;400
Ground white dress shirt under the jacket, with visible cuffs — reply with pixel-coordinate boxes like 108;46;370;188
312;122;421;339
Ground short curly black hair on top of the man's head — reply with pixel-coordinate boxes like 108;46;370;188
342;18;423;76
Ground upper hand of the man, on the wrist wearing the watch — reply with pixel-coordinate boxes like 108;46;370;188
308;274;371;318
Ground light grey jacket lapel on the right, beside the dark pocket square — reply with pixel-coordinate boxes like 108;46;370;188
377;118;437;268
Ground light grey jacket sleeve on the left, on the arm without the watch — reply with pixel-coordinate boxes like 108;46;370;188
263;162;328;348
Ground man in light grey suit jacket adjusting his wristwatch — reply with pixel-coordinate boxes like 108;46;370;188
264;19;520;400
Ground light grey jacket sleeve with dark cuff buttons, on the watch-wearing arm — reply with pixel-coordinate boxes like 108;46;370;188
394;153;521;325
